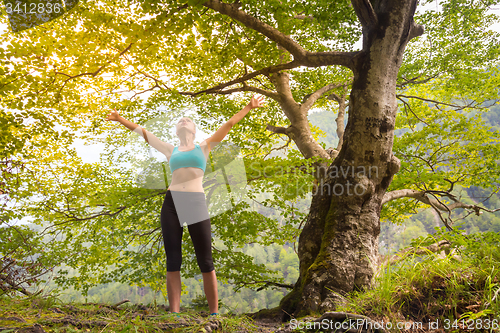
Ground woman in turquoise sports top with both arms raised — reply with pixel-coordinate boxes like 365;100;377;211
107;96;263;315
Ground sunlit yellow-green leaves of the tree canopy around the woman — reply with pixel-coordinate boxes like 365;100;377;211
0;0;500;302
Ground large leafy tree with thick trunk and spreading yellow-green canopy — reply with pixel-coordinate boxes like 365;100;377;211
2;0;499;315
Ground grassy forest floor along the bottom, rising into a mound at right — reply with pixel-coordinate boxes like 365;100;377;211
0;233;500;333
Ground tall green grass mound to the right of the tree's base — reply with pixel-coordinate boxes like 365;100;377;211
337;230;500;332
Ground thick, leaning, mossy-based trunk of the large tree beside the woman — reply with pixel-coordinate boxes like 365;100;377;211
280;0;416;319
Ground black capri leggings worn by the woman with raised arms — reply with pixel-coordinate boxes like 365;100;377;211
161;190;214;273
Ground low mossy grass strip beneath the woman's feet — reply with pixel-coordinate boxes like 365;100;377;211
0;296;266;333
